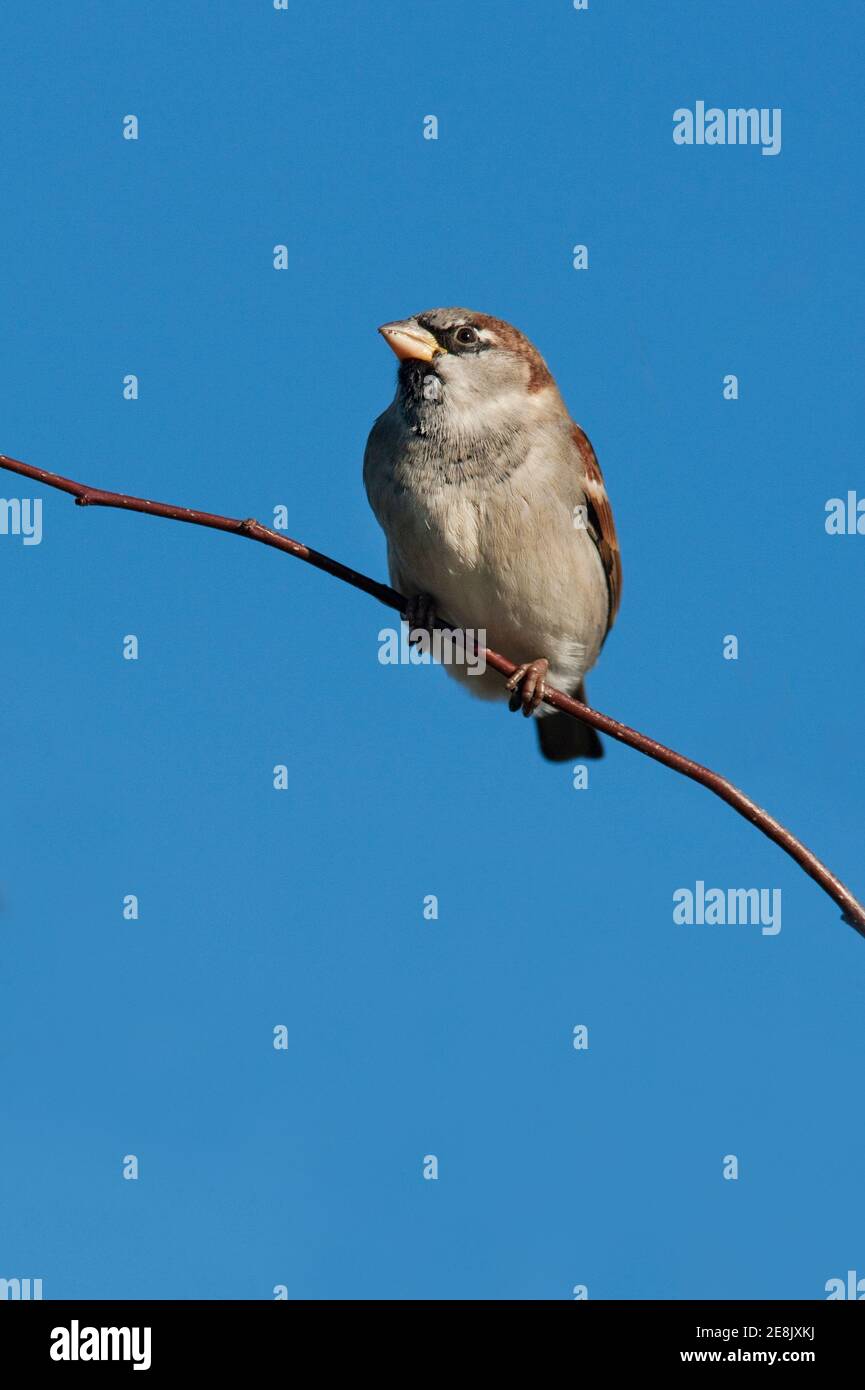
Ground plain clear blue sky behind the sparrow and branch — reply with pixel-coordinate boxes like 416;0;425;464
0;0;865;1300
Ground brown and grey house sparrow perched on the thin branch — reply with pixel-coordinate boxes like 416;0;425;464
363;309;622;762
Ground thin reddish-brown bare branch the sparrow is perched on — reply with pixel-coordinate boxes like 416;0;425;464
0;455;865;937
